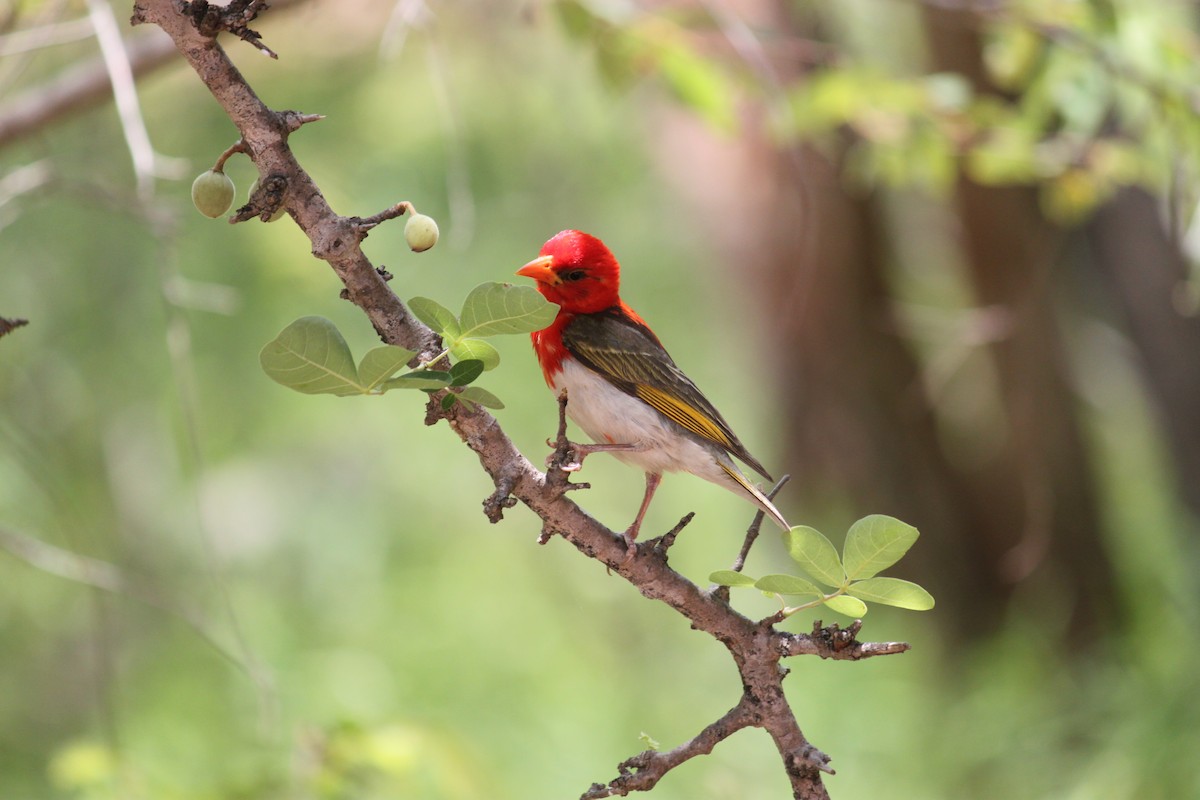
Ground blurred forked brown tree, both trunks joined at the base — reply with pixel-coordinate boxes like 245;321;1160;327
660;0;1112;638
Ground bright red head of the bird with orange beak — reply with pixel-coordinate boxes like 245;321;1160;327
517;230;620;314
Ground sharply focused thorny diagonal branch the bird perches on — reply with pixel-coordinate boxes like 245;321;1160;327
133;0;908;800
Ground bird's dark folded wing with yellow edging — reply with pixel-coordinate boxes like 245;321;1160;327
563;307;773;480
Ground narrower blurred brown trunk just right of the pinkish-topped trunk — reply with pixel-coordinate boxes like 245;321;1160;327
923;6;1115;631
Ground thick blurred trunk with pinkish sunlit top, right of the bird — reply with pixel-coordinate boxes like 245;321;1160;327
659;114;1020;634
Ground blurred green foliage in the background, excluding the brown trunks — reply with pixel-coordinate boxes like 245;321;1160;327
0;0;1200;800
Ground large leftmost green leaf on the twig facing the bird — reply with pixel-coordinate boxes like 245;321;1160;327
258;317;367;397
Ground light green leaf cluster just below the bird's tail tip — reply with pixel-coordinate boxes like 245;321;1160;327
708;515;934;616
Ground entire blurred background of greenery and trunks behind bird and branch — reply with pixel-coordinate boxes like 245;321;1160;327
0;0;1200;800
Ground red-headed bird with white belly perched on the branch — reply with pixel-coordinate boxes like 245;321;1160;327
517;230;788;554
